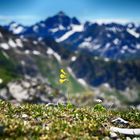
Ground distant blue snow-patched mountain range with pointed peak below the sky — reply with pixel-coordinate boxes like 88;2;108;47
4;12;140;59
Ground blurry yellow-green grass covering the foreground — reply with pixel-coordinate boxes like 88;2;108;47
0;101;140;140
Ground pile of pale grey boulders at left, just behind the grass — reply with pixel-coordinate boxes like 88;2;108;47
0;77;67;104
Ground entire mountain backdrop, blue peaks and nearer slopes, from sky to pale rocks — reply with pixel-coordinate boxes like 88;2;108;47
0;12;140;105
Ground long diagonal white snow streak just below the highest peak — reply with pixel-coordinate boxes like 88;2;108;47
56;24;84;42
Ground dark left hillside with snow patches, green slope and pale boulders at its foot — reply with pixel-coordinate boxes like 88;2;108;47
0;26;84;103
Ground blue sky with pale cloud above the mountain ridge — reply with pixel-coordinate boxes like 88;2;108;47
0;0;140;25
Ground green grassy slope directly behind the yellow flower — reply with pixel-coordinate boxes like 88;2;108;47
35;56;85;94
